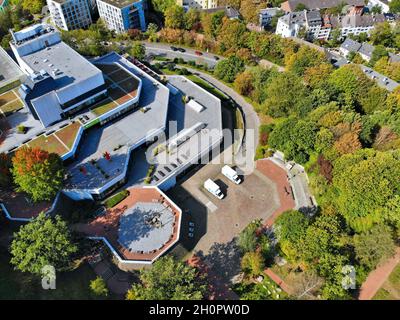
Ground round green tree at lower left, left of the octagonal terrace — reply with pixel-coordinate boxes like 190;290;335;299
10;213;78;275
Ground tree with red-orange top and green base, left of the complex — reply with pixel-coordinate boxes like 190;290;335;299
11;147;64;201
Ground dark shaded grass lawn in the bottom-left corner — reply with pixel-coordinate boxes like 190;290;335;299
0;252;110;300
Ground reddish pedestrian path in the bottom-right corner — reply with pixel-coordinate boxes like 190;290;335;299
358;248;400;300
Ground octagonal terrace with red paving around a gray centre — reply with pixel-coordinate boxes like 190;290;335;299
77;187;182;262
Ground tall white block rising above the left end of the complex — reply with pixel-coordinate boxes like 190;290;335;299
10;24;107;127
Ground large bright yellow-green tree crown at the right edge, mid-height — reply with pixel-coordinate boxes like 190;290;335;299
333;149;400;232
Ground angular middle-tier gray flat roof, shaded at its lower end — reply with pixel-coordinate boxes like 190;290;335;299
68;53;169;190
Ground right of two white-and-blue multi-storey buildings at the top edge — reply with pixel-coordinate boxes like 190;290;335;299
97;0;147;33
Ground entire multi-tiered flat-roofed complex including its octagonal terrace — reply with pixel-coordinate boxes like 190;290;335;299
0;25;223;265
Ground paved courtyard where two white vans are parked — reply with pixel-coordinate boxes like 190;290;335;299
168;164;280;254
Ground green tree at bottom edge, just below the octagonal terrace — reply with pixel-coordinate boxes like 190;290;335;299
127;256;206;300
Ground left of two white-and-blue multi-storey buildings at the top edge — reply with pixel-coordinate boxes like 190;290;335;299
47;0;94;31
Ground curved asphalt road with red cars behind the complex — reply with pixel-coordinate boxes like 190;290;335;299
143;42;223;68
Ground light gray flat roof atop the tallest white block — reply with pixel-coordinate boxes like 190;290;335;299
22;41;101;88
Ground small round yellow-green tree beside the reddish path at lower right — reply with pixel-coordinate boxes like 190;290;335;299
354;225;396;270
